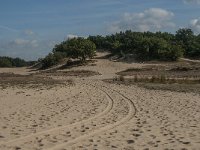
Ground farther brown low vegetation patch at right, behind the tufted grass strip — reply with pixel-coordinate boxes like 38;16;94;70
116;63;200;79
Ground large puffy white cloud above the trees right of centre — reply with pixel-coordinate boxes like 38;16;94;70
109;8;176;32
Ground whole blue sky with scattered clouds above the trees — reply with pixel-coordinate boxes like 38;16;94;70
0;0;200;60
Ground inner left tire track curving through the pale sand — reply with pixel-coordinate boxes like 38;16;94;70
0;84;114;146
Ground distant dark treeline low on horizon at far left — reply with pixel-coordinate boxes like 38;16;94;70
0;56;35;67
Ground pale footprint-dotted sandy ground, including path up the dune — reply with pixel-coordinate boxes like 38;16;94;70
0;52;200;150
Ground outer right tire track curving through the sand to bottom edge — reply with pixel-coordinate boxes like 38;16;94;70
45;84;137;150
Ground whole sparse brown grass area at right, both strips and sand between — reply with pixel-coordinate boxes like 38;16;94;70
107;62;200;93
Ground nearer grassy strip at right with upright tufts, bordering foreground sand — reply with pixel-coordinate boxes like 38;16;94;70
104;76;200;94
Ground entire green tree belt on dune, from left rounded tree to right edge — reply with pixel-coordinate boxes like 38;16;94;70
39;28;200;69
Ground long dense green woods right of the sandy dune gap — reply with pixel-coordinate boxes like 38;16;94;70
88;28;200;61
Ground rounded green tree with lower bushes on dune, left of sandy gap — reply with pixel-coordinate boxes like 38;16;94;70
41;38;96;69
